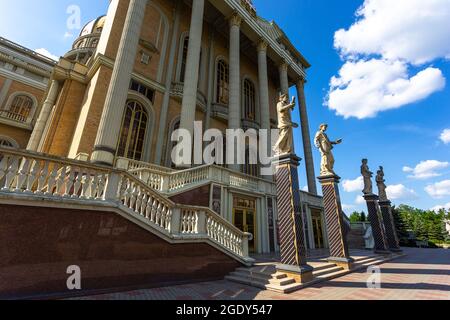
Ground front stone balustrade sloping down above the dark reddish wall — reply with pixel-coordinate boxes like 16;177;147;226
0;147;252;264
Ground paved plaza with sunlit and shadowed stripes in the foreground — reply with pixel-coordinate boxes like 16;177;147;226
75;248;450;300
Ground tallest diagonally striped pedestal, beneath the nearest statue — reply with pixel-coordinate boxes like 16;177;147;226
273;154;313;283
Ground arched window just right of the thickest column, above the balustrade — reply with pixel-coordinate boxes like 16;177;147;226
117;100;148;161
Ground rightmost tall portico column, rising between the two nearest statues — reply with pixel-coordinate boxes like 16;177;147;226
297;79;317;195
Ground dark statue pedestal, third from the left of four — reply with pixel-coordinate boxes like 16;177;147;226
364;194;390;254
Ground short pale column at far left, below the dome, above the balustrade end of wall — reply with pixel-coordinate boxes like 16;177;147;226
27;80;60;151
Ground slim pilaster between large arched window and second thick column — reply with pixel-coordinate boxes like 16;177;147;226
155;1;181;165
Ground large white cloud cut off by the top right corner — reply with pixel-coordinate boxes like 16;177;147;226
335;0;450;65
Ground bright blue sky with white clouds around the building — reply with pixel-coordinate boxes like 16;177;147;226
0;0;450;212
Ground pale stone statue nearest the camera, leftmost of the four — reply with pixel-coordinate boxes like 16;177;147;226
274;94;298;156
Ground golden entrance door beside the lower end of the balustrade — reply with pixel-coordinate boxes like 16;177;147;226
233;198;256;252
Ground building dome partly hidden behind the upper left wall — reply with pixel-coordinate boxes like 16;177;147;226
64;16;106;64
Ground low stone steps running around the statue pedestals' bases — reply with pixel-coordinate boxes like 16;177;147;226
225;254;399;293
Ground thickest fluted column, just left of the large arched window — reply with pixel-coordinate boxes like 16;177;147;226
91;0;147;165
